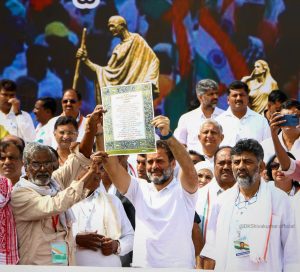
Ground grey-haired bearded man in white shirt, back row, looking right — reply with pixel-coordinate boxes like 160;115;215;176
174;79;223;150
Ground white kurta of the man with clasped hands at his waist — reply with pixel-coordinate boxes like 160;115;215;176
72;189;134;267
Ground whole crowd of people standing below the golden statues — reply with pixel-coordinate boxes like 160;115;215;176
0;73;300;271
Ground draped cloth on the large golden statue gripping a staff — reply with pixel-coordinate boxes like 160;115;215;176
95;33;159;92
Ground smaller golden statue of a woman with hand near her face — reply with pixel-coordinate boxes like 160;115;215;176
241;60;278;114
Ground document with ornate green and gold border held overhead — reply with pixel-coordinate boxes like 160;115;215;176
101;82;156;155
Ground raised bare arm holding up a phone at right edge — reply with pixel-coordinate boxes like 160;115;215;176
270;113;291;171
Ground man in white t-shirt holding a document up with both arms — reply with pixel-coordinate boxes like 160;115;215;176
97;116;198;268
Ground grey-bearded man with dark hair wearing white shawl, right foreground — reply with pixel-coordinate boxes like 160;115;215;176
201;139;299;271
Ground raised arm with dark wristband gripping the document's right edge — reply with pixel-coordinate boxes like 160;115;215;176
151;115;198;194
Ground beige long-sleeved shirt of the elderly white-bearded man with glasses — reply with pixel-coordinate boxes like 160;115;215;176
11;148;90;265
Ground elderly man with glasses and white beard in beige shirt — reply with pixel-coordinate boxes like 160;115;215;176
11;143;99;265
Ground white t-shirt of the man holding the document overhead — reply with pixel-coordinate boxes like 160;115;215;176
125;177;198;268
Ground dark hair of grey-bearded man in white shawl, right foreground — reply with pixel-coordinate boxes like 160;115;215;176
230;139;264;161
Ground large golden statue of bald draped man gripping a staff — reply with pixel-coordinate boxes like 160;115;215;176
76;16;159;93
